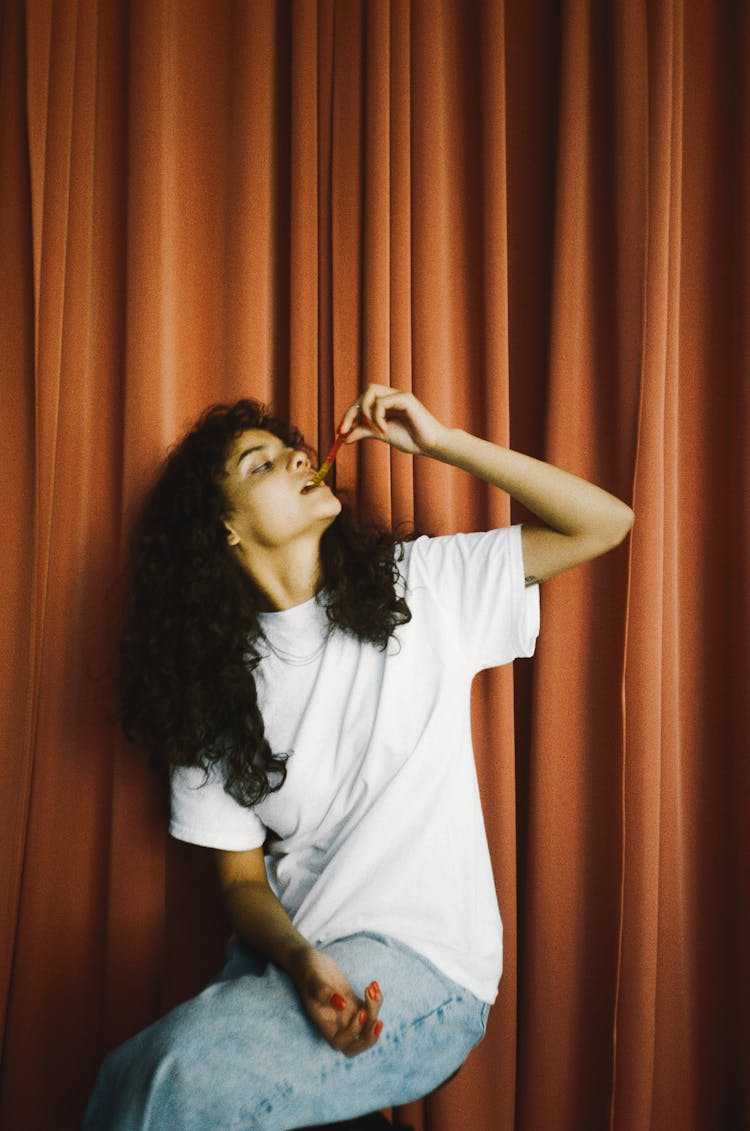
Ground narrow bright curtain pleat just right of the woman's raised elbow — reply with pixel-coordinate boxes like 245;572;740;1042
612;5;695;1128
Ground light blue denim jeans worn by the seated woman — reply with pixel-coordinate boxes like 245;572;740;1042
84;934;490;1131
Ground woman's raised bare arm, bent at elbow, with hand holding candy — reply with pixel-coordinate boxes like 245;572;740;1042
342;385;633;585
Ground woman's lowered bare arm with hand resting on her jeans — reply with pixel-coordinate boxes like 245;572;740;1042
215;848;382;1056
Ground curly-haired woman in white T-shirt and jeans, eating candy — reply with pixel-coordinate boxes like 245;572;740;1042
85;385;632;1131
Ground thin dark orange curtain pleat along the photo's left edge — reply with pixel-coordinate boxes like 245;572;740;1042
0;0;36;1067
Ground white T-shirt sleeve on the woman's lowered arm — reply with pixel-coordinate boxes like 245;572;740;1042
170;766;266;852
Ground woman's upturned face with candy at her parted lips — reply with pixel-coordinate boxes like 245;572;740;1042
223;429;342;554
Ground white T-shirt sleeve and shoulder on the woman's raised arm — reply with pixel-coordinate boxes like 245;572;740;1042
407;526;540;672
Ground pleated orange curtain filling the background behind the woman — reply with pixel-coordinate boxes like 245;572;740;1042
0;0;750;1131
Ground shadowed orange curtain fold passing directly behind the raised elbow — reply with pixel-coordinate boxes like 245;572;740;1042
510;3;649;1128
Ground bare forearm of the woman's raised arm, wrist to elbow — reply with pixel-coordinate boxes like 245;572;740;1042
425;429;632;549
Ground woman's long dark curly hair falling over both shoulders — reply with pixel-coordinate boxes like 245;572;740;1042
117;399;411;805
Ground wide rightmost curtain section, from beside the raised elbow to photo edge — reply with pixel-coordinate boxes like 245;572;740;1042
613;3;750;1128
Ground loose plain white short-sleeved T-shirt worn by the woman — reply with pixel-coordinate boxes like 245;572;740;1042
170;527;538;1002
